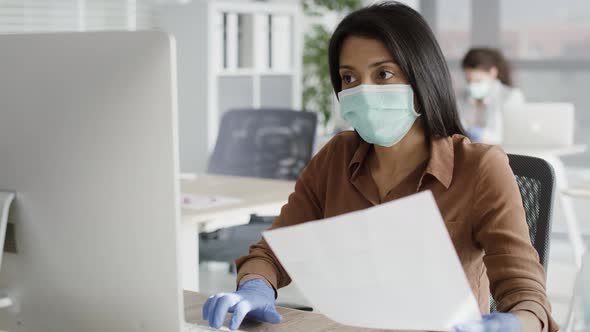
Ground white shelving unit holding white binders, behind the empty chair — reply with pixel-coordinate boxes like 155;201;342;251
160;0;303;173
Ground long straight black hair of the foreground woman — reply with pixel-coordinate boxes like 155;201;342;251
328;1;465;138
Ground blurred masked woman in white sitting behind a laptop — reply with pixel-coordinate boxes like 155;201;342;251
459;48;524;144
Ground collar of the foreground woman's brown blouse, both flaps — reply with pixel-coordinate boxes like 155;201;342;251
348;135;455;189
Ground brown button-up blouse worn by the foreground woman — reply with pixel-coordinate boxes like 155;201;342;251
236;131;558;331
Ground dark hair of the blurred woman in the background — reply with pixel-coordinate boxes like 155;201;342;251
461;47;514;86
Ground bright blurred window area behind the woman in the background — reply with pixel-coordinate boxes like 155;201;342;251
430;0;590;167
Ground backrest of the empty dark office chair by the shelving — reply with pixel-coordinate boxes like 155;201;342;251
207;109;317;180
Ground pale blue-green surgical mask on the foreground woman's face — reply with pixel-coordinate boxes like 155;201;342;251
338;84;419;147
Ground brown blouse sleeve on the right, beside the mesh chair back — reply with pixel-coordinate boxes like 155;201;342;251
471;147;558;331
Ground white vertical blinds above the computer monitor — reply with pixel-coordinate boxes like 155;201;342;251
0;0;156;33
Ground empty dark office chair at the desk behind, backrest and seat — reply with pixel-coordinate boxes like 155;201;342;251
199;109;317;269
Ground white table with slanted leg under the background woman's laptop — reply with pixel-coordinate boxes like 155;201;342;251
503;144;586;267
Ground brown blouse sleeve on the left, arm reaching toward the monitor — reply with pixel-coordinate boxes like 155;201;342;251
236;139;335;290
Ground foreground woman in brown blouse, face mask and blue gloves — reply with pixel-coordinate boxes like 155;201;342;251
203;2;558;332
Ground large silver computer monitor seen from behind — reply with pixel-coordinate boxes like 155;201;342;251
0;32;194;332
